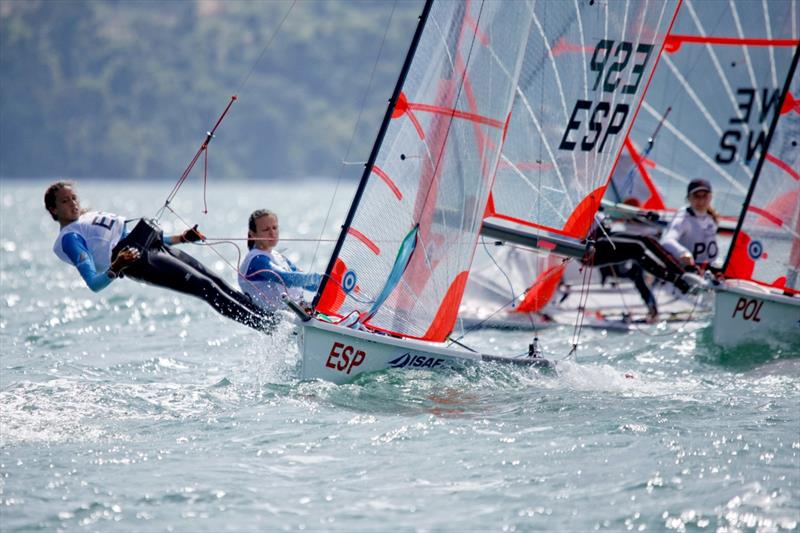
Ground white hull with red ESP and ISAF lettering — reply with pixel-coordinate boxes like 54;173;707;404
299;320;551;384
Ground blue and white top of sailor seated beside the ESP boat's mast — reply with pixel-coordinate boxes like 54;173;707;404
239;248;322;311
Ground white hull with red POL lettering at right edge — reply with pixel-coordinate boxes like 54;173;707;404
713;280;800;346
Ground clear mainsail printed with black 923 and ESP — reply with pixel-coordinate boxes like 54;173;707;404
486;2;676;312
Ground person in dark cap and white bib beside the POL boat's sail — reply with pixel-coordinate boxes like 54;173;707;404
661;179;719;273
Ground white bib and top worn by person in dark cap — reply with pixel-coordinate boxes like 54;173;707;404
661;207;719;265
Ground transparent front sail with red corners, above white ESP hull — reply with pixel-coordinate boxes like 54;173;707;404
317;1;531;341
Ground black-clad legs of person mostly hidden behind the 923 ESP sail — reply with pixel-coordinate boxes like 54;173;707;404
584;208;693;322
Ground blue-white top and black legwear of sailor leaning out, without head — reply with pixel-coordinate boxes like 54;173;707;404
53;211;272;330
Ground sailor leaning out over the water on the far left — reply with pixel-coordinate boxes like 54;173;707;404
44;181;272;330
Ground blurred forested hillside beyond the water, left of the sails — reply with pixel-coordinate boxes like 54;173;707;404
0;0;421;178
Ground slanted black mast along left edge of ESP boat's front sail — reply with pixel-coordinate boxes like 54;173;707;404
311;0;433;309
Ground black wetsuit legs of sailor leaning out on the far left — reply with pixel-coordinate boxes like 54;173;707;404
112;238;274;330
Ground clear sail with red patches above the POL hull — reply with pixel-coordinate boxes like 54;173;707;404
724;46;800;295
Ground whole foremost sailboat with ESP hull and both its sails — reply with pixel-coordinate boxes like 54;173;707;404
287;0;679;383
